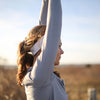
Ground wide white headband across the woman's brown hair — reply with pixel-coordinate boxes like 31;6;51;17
31;36;44;55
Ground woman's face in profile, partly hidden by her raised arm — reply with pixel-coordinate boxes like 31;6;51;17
55;40;64;65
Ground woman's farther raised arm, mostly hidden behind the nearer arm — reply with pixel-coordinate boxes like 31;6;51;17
39;0;48;25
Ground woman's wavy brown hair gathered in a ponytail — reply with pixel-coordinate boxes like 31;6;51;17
17;25;46;85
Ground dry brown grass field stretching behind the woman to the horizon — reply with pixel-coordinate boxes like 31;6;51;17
0;65;100;100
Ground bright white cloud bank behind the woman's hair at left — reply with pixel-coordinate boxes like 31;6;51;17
0;11;38;64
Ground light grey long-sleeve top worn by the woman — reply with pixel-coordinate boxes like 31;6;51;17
23;0;67;100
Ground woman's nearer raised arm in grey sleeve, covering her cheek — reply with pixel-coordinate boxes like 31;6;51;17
31;0;62;86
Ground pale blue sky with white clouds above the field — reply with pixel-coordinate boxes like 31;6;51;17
0;0;100;64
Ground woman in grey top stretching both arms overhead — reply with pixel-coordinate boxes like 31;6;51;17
17;0;67;100
